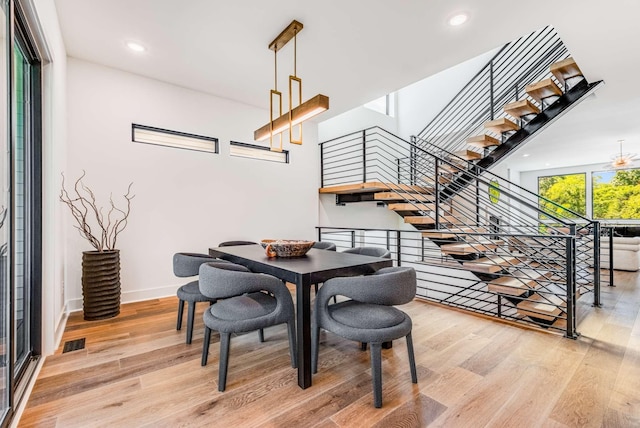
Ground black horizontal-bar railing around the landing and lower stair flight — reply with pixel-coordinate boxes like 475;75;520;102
320;127;601;337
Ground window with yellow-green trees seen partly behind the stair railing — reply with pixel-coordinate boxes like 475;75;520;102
538;173;587;218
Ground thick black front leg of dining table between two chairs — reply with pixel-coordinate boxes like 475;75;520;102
296;279;311;389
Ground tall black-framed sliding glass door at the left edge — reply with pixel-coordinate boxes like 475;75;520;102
0;0;42;427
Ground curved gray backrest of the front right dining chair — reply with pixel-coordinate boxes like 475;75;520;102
317;266;417;306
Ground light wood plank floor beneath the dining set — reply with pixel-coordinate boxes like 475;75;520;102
19;273;640;428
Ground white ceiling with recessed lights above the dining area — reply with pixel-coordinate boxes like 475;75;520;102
55;0;640;170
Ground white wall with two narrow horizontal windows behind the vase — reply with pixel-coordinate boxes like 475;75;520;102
65;58;319;308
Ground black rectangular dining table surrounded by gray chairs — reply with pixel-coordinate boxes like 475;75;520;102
209;244;393;389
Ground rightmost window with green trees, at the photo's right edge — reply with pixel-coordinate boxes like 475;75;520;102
591;168;640;220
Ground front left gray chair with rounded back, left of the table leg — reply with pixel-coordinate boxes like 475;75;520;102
200;263;297;391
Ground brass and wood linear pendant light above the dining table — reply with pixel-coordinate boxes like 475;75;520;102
253;20;329;151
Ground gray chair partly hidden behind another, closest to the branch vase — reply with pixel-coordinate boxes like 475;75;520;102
173;253;217;344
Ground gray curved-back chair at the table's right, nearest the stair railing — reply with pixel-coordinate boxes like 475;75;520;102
312;267;418;407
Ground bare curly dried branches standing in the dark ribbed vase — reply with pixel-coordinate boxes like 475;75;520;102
60;171;135;252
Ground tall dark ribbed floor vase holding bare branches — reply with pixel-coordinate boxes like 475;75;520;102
82;250;120;321
